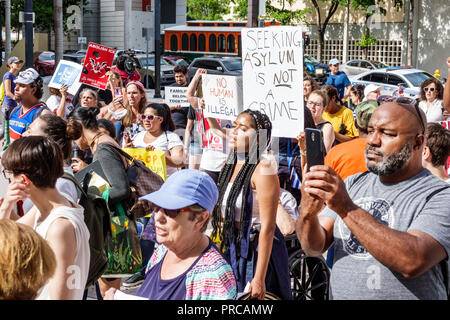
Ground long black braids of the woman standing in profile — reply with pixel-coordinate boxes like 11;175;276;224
212;109;272;255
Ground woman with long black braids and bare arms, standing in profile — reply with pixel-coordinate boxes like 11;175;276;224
212;110;292;299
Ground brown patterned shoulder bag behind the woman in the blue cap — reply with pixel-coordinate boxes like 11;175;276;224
106;144;164;219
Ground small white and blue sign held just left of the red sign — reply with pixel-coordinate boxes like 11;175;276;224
48;60;83;96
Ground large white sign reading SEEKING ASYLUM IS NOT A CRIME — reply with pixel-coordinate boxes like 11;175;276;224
241;26;304;138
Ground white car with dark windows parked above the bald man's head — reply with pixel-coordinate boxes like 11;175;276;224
349;67;434;99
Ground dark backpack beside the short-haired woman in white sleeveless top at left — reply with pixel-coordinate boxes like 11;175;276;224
62;172;111;289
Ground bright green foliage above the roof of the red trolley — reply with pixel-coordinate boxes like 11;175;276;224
186;0;230;20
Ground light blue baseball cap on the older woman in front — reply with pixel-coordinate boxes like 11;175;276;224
139;169;219;213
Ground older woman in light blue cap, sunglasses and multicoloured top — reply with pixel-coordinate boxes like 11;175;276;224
105;169;237;300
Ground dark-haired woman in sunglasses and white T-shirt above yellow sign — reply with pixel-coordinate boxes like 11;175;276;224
127;103;184;176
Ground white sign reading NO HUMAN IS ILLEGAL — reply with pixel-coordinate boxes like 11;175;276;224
202;74;242;120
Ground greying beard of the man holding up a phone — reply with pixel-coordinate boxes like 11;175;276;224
365;142;412;176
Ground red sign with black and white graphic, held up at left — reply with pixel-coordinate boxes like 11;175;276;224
80;42;116;90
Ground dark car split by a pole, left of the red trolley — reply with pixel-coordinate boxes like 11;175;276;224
134;54;175;89
